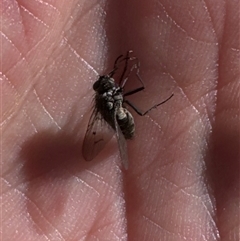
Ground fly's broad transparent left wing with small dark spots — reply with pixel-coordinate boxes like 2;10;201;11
82;109;114;161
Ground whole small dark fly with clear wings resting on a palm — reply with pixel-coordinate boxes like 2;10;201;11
82;51;173;169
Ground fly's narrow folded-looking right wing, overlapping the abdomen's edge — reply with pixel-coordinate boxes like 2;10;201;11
114;111;128;170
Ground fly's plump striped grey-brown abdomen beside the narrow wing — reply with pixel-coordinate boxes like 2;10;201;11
117;108;135;139
